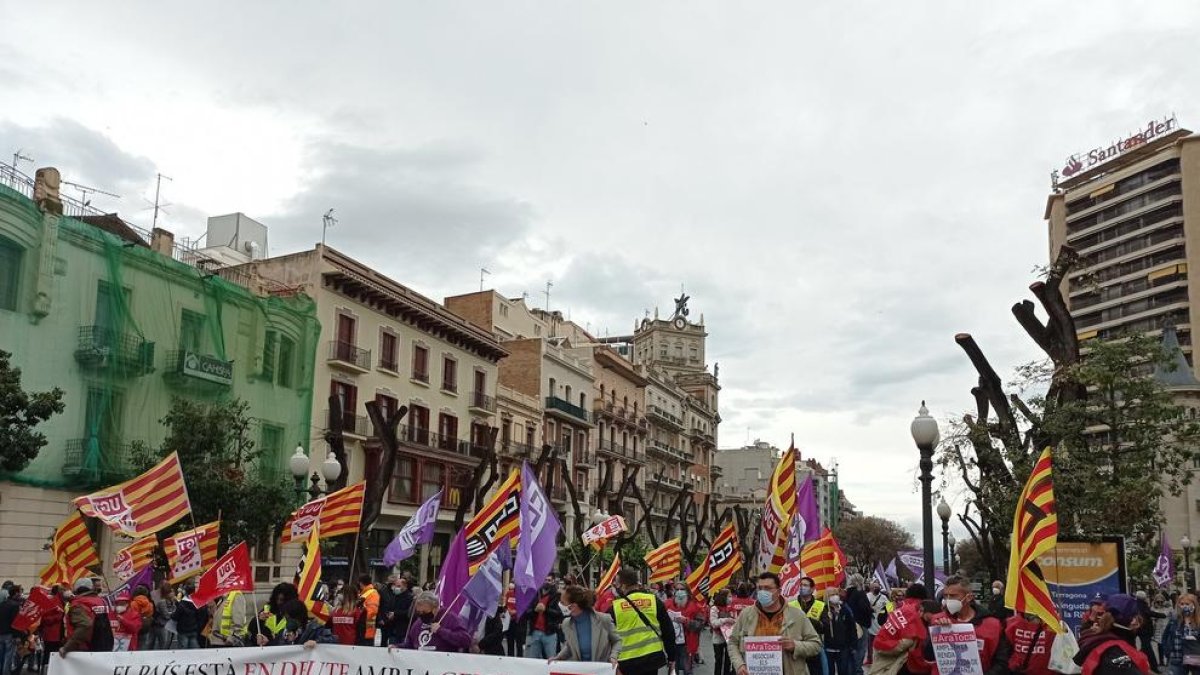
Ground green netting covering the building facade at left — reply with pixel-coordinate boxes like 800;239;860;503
0;186;320;490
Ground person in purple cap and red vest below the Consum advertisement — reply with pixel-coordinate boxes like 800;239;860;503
1074;593;1151;675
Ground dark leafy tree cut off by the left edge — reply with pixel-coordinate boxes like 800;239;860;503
0;350;62;472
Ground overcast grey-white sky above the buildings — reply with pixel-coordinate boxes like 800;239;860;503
0;0;1200;531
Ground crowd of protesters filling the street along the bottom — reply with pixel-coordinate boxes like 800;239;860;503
0;569;1171;675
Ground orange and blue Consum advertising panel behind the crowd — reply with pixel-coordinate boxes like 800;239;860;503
1038;537;1126;635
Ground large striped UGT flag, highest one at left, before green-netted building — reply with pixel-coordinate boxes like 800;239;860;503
73;453;192;538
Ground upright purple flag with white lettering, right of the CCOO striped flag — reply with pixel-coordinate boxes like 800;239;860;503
512;462;562;616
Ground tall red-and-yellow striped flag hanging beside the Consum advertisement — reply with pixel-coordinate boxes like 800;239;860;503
1004;448;1062;629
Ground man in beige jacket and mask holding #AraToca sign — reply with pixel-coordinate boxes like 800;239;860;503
728;572;821;675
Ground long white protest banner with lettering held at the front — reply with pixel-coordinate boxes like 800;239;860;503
49;645;613;675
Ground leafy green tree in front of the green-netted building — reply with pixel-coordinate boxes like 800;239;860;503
133;398;295;550
